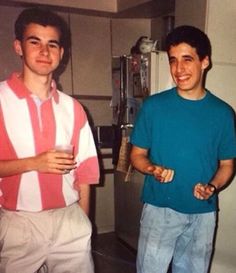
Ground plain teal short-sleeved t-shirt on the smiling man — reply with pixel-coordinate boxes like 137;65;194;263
131;88;236;213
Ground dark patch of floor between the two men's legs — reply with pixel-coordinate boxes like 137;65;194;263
93;233;136;273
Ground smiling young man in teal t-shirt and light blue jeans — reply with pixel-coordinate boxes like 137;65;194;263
131;26;236;273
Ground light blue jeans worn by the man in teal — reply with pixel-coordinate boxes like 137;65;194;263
137;204;216;273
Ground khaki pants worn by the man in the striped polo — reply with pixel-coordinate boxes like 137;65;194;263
0;203;94;273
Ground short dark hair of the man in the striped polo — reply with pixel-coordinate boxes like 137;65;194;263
15;7;69;47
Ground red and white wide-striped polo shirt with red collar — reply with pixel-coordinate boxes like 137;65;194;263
0;73;99;211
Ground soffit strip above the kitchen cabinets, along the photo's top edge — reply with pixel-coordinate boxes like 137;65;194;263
0;0;175;18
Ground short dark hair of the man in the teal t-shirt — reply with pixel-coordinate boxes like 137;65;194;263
166;25;211;60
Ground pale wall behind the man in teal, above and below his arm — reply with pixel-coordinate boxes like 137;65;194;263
206;0;236;273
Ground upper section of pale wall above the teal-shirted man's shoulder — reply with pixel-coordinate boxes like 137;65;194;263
205;0;236;110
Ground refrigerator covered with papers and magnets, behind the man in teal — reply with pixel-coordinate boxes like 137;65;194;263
112;51;173;249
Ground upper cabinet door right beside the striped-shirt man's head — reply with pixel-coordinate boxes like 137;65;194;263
71;14;112;96
